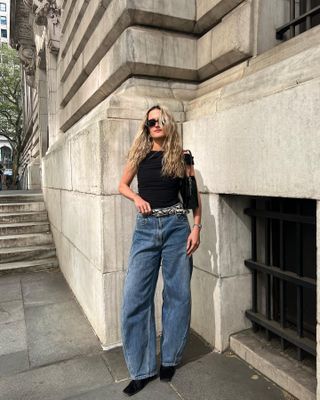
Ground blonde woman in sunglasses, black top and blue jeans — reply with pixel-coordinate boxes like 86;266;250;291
119;106;201;396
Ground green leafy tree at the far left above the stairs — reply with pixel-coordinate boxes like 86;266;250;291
0;44;23;188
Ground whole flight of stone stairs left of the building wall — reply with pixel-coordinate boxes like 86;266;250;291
0;191;58;273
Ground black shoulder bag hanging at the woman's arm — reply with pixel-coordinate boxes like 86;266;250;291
180;150;199;210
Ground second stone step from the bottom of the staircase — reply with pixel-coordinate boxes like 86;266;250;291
0;243;56;263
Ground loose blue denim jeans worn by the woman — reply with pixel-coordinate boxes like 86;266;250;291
122;214;192;379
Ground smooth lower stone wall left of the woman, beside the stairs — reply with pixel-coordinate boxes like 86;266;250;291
43;108;134;346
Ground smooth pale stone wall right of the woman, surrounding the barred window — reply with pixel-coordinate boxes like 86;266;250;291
183;27;320;350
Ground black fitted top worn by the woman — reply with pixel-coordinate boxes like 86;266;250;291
137;151;193;209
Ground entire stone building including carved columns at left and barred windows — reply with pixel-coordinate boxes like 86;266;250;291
11;0;320;399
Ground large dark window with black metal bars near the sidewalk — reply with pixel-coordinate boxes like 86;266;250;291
244;197;316;360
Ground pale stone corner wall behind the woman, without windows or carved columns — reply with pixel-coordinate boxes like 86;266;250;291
42;0;320;368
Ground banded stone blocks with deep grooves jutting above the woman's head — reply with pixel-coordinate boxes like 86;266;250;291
58;0;254;131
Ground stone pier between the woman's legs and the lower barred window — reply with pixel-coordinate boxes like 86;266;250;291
191;171;251;351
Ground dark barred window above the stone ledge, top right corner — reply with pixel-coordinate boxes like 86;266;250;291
276;0;320;40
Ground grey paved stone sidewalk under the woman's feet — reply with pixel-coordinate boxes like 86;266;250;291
0;270;293;400
